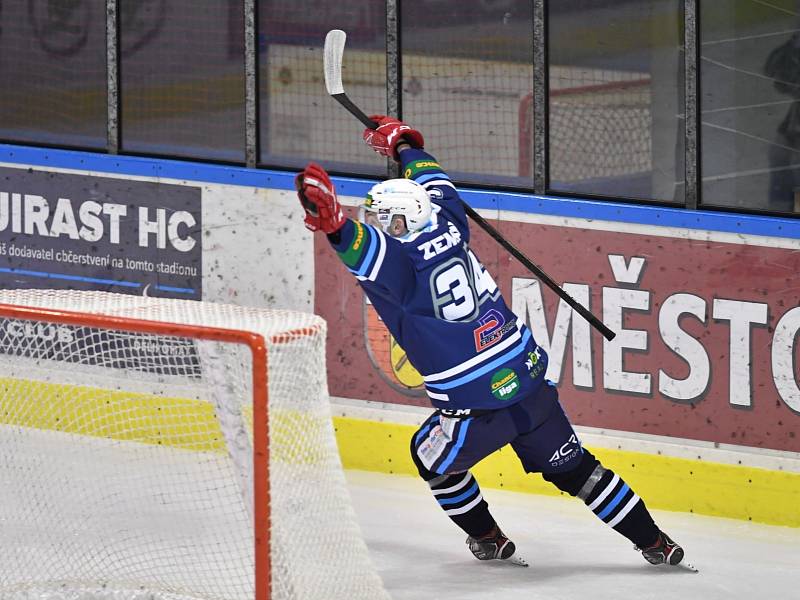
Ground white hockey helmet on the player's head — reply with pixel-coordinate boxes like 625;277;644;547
361;179;431;233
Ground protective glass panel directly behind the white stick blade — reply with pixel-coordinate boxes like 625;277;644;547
258;0;386;175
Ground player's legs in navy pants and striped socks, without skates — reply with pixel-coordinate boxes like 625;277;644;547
411;383;658;548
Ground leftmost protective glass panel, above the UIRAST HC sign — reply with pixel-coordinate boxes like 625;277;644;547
0;0;107;149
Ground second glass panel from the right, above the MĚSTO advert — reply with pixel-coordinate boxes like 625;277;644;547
548;0;685;203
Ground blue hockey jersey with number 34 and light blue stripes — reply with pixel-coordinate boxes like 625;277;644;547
333;149;547;412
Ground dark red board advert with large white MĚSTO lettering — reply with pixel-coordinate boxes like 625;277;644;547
315;194;800;452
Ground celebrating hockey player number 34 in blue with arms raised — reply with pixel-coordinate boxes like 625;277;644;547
295;116;684;566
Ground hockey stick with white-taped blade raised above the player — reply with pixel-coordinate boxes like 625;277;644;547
324;29;617;341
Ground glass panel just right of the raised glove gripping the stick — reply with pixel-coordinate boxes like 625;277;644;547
401;0;533;188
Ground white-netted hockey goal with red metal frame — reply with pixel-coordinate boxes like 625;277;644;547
0;290;388;600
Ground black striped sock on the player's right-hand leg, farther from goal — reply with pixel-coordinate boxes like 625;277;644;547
577;463;658;548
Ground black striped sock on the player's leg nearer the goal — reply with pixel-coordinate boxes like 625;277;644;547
428;471;496;537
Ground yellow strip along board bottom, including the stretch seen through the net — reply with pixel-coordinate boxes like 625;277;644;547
0;378;800;527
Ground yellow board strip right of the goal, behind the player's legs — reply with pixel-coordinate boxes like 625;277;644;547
334;416;800;527
